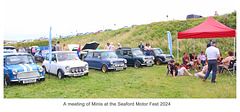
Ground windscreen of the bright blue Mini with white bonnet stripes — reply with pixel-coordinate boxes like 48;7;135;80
6;55;34;65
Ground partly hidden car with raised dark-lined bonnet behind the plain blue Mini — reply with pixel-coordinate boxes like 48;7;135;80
79;42;99;60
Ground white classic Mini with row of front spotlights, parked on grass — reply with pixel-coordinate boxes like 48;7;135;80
42;51;89;79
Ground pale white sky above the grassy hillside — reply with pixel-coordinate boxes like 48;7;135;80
2;0;237;40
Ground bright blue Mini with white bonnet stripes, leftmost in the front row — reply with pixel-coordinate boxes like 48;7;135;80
3;53;45;86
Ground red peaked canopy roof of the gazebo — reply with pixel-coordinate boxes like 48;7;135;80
178;17;236;39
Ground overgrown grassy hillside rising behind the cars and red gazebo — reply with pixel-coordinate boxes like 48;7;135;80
9;12;236;57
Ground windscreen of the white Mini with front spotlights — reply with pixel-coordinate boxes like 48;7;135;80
57;53;79;61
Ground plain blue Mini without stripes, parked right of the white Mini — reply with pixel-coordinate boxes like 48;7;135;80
84;50;127;72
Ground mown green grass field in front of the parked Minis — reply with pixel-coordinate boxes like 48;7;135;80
4;62;236;98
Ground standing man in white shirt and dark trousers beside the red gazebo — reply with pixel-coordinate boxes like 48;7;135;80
203;40;220;83
